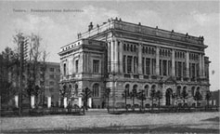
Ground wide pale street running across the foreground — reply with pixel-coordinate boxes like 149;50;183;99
1;110;219;133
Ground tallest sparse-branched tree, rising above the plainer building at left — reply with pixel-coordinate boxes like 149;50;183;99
13;33;47;109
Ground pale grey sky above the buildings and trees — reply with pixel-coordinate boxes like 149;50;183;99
0;1;220;91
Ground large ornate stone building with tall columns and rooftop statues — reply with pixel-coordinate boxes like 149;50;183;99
59;18;210;108
